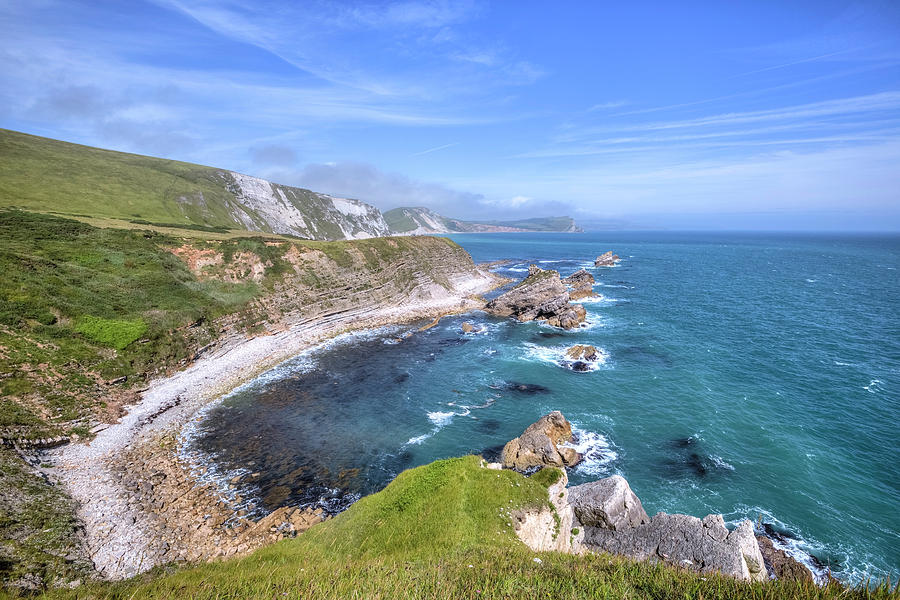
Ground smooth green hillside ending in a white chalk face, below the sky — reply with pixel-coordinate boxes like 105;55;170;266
0;129;390;240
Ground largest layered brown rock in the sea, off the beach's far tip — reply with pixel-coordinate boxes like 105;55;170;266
485;267;586;329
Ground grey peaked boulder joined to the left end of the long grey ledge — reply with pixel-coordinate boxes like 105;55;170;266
569;475;650;531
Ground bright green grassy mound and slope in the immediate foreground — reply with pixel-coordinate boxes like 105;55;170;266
15;456;891;600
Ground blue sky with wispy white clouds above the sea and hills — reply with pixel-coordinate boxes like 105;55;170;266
0;0;900;230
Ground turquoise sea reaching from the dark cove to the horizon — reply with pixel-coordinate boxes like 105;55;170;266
184;233;900;581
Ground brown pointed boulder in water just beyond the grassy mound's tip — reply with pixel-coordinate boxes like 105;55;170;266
500;410;582;471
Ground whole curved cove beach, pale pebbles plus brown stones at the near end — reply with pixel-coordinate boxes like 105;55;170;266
44;270;504;580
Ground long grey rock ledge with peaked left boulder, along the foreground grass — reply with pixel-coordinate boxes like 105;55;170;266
570;478;768;581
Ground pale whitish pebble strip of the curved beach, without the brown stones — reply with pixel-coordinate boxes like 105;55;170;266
46;269;505;579
